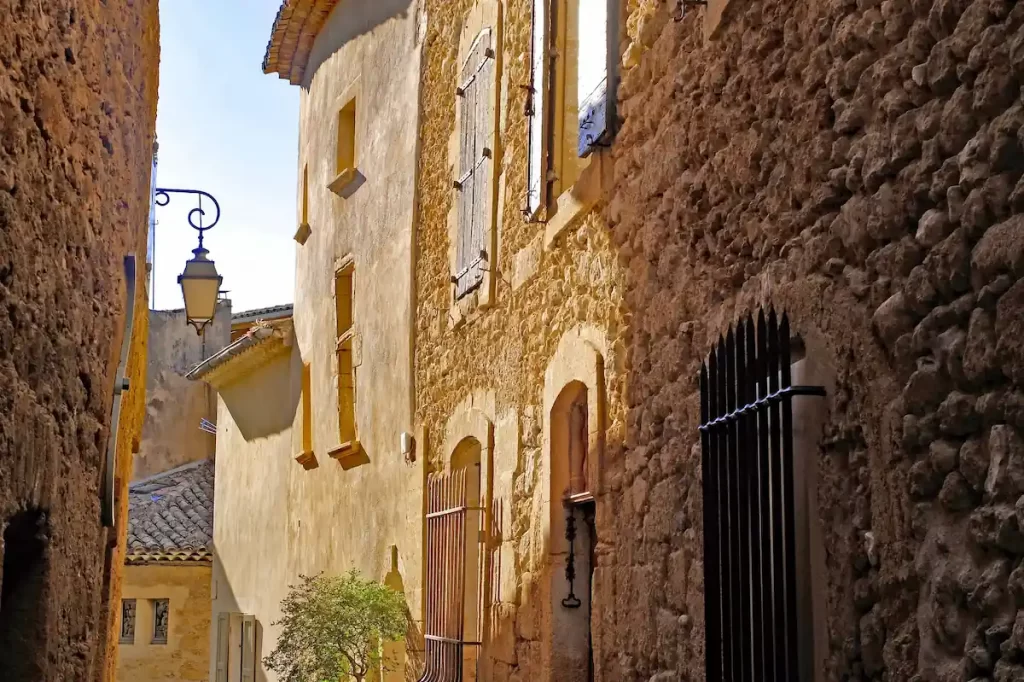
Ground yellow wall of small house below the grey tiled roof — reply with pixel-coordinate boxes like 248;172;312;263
117;564;211;682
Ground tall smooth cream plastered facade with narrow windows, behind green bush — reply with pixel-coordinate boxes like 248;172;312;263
210;0;424;682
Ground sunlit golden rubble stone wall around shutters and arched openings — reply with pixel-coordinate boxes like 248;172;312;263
416;0;626;682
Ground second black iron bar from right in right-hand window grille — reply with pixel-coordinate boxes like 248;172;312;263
768;309;796;682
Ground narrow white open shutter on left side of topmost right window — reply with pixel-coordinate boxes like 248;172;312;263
526;0;552;219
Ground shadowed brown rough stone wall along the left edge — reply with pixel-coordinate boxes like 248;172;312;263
0;0;159;682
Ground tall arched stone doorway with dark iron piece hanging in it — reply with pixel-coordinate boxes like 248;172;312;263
538;327;606;682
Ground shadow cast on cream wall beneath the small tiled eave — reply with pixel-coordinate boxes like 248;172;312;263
220;353;301;441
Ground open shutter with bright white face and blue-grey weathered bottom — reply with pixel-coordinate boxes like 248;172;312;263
577;0;618;157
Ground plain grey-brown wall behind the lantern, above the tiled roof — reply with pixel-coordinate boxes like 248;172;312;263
132;301;231;480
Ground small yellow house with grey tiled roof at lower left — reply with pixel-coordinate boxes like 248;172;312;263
118;460;214;682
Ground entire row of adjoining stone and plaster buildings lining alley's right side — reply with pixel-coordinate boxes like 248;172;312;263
220;0;1024;682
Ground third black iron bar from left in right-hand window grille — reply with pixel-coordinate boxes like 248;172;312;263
715;337;735;682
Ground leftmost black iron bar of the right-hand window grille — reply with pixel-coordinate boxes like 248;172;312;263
700;364;722;682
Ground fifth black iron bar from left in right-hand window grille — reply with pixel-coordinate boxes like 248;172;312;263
734;323;754;682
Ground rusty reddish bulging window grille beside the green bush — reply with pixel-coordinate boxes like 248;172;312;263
420;469;480;682
